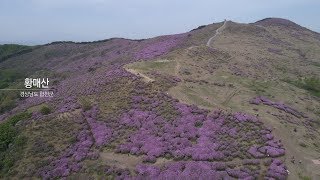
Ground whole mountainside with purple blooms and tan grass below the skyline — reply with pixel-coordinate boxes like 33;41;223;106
0;19;320;180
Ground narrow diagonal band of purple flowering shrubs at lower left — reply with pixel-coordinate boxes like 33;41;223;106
39;106;112;179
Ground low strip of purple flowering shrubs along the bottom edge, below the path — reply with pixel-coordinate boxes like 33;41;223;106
136;161;259;179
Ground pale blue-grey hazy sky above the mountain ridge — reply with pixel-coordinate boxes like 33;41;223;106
0;0;320;44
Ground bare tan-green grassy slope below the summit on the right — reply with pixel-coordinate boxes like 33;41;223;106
127;20;320;178
